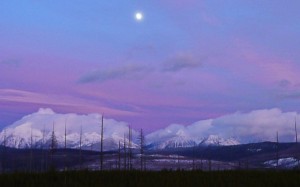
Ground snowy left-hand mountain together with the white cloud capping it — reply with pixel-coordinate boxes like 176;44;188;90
0;109;137;150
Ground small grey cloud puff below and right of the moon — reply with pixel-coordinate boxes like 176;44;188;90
163;53;203;72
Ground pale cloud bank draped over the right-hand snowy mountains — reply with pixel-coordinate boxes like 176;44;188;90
148;108;300;143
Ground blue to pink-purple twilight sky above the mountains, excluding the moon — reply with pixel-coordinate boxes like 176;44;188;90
0;0;300;132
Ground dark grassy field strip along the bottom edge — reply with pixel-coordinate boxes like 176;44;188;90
0;171;300;187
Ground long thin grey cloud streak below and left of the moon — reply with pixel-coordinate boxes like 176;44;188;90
78;64;149;84
